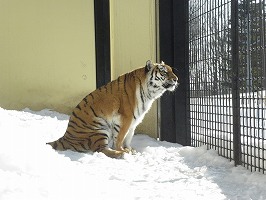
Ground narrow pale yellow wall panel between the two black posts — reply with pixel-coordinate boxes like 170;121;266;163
110;0;157;137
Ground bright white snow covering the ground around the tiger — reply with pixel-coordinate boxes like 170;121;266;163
0;108;266;200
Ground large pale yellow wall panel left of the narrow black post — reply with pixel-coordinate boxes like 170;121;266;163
0;0;96;113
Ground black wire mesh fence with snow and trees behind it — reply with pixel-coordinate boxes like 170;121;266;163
188;0;266;173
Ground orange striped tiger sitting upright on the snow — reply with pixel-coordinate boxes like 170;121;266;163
47;60;179;158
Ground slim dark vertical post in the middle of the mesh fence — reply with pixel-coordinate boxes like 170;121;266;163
231;0;242;165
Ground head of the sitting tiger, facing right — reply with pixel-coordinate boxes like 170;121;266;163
145;60;179;92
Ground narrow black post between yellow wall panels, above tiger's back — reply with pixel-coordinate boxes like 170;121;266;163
94;0;111;88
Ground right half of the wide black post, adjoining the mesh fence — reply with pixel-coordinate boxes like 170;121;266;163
173;0;190;145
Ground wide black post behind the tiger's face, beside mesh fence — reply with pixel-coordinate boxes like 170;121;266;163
159;0;190;145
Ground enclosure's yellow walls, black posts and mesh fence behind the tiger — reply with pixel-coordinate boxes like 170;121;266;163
0;0;266;173
